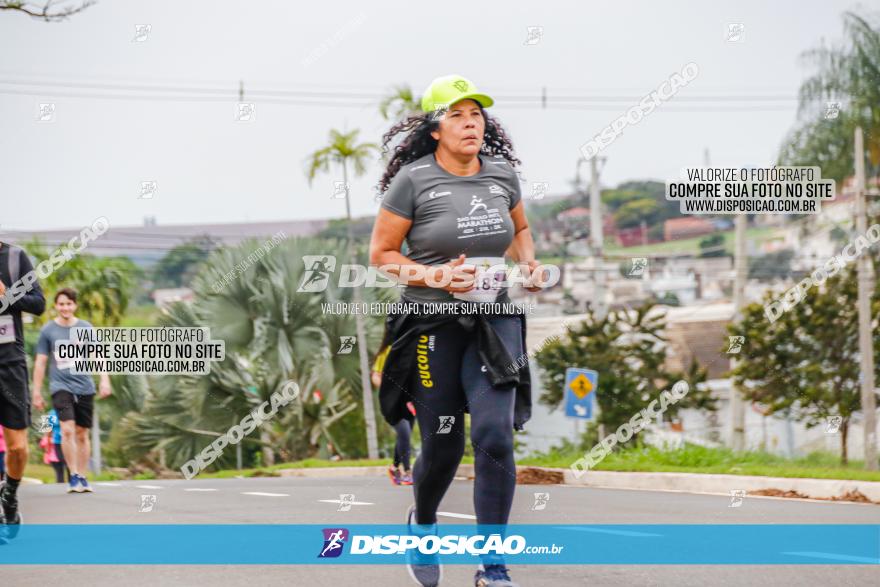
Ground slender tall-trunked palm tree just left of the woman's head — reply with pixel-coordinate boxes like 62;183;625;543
306;130;379;459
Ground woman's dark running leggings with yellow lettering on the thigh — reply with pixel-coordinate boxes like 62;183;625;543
410;316;522;524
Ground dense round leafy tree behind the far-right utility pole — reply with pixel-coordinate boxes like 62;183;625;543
728;267;880;463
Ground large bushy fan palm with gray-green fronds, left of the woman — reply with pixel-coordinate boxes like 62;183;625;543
119;238;390;467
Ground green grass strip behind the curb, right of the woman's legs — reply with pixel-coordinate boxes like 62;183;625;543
517;445;880;481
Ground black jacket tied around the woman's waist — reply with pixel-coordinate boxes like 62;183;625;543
379;298;532;430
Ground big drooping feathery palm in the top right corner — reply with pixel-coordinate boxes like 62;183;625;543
780;12;880;180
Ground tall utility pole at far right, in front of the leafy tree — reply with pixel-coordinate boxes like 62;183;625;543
855;126;877;471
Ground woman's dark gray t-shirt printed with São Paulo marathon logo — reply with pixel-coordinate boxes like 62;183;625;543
382;153;522;302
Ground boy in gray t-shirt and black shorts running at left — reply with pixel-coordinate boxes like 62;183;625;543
33;287;111;493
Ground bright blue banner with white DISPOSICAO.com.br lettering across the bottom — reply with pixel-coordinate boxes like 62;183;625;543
0;524;880;565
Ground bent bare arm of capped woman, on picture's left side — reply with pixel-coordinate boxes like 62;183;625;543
370;208;475;293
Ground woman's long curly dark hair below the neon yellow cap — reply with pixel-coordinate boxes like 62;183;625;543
377;106;522;194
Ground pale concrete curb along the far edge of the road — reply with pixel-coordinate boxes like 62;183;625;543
277;464;880;502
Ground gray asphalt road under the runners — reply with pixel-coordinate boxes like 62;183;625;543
0;477;880;587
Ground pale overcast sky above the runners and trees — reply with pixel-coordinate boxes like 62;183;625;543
0;0;880;232
